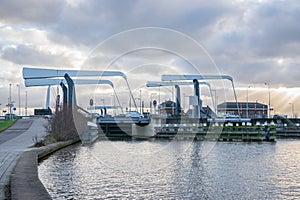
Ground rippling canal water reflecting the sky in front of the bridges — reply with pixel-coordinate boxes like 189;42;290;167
38;140;300;199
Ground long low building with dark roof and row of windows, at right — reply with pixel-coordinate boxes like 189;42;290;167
217;102;269;119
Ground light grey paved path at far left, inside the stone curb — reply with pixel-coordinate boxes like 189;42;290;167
0;118;47;200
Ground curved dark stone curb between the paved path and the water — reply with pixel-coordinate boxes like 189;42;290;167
10;138;80;200
